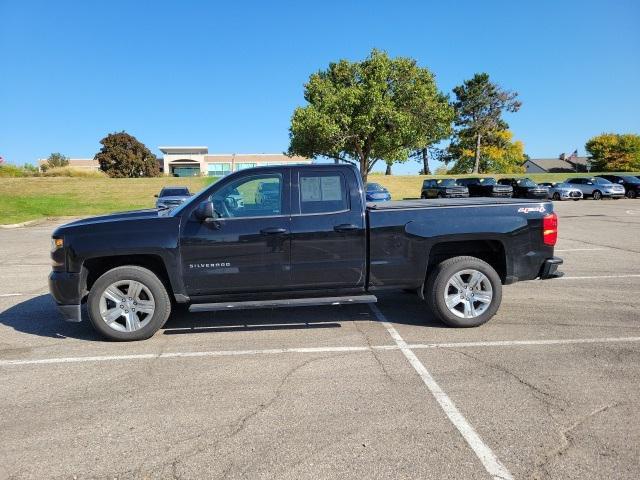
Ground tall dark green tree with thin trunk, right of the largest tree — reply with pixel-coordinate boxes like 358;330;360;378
453;73;522;173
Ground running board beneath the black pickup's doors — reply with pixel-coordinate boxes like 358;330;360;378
189;295;378;312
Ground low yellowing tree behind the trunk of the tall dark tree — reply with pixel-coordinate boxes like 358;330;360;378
444;130;525;174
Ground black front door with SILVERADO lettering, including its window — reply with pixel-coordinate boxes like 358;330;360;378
181;172;291;295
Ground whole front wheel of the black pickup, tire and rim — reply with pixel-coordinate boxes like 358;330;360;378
87;265;171;342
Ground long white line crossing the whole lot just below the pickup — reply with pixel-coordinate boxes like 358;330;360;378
0;337;640;367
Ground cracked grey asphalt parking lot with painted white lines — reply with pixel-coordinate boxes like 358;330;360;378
0;200;640;479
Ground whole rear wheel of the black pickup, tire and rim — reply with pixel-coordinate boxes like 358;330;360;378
424;256;502;327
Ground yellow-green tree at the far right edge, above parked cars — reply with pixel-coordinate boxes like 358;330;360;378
585;133;640;172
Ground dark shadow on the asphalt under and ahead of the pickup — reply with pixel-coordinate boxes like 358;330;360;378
0;293;447;341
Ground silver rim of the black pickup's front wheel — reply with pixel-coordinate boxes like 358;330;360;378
100;280;156;332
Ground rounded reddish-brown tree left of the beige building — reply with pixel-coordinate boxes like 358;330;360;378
94;131;160;178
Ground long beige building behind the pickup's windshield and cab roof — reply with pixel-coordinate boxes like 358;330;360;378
158;146;312;177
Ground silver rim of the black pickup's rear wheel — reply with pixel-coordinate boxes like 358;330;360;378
444;269;493;318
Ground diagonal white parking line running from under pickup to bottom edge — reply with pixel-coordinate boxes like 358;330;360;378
369;304;513;480
